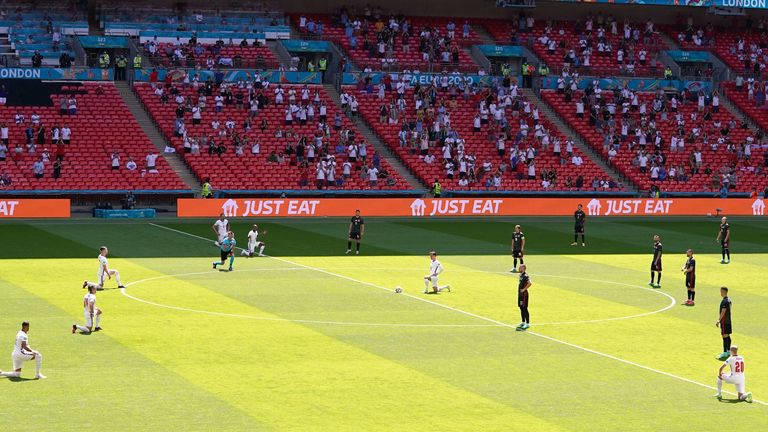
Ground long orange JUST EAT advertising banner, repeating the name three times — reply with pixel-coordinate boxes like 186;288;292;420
177;198;765;218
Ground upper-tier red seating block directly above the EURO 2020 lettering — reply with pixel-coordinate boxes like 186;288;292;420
291;14;480;73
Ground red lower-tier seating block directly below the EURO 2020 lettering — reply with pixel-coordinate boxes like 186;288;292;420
346;86;616;191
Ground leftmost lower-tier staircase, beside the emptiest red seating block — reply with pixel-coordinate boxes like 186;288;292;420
115;81;200;191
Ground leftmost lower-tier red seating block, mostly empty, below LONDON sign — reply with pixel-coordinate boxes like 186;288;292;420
0;83;187;190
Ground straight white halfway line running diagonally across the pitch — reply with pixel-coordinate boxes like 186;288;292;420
150;222;768;406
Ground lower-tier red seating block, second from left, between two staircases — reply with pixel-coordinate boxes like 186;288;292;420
135;84;410;190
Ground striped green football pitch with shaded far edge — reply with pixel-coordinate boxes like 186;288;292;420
0;215;768;431
